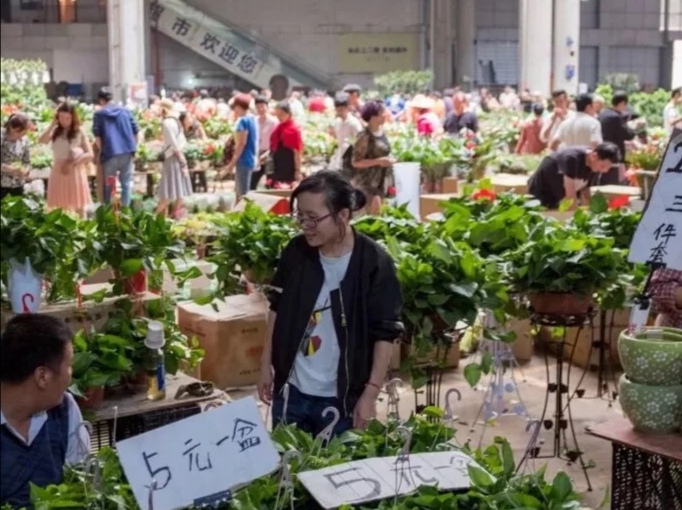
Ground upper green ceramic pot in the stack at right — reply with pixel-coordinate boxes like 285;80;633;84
618;328;682;386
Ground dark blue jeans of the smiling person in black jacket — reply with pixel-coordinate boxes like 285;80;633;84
272;384;353;437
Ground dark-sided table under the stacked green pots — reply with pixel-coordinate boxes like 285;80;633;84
587;418;682;510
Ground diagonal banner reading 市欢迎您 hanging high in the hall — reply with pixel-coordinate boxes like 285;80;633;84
149;0;264;83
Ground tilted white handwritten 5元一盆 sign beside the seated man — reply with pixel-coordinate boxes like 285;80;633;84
116;397;279;510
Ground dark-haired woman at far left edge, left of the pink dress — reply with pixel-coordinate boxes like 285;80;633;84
0;113;31;200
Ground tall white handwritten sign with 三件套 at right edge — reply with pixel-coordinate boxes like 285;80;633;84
628;134;682;270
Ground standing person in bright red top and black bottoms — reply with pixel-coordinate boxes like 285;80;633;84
269;101;303;187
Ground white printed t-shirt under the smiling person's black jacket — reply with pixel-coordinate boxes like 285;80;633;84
290;252;352;397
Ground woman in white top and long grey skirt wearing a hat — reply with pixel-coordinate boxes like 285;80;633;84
156;99;192;218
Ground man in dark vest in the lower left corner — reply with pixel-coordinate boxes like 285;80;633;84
0;314;90;508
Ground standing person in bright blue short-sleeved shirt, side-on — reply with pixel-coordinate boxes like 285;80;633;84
225;94;258;200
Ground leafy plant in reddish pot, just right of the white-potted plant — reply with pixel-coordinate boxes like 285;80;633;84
93;205;184;295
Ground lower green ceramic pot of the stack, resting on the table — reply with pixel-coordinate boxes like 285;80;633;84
618;374;682;434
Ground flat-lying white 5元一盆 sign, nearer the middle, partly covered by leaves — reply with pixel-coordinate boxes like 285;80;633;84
298;451;476;509
